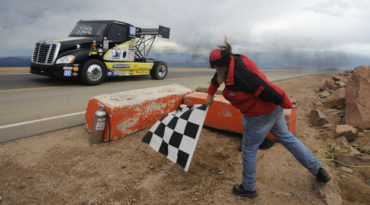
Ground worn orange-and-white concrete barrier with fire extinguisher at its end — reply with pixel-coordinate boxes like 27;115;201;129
85;84;192;141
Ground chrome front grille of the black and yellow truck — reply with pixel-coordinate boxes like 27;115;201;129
32;42;60;65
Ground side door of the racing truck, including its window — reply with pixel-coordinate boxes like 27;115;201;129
104;24;135;61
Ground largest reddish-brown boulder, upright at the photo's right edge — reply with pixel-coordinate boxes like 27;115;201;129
345;66;370;130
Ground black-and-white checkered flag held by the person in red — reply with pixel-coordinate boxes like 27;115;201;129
141;104;208;171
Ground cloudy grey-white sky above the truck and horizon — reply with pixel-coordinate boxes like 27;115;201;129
0;0;370;68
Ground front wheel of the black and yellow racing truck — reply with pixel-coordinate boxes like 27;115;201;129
81;59;107;85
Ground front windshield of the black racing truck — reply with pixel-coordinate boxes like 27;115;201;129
69;21;108;37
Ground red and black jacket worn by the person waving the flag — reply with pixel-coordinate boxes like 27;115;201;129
208;55;292;117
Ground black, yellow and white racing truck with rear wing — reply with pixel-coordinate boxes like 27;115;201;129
30;20;170;85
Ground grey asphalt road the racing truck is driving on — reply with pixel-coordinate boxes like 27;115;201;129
0;68;332;142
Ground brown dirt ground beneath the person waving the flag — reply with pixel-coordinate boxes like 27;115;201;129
0;75;370;205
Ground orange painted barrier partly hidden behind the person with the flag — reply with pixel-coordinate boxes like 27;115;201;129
184;92;296;140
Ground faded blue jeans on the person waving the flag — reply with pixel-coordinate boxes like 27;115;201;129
242;106;323;191
